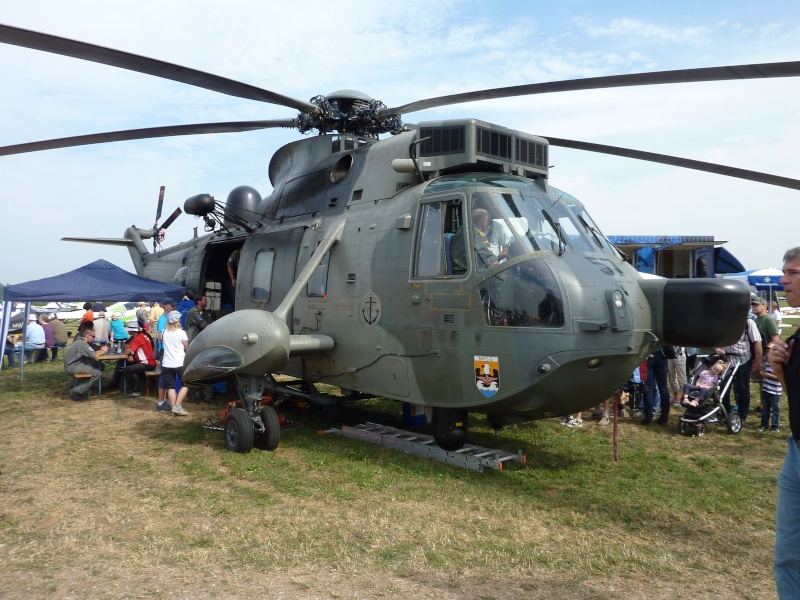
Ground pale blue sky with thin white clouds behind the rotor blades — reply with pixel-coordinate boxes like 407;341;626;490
0;0;800;283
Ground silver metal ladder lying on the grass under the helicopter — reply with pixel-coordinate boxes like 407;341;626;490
326;422;525;472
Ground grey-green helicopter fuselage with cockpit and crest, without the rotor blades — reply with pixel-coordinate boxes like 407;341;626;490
126;122;746;425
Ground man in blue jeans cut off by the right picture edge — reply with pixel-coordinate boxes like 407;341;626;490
769;246;800;600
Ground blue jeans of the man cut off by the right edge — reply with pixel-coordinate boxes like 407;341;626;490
772;437;800;600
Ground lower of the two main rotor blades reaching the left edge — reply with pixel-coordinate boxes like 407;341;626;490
0;119;295;156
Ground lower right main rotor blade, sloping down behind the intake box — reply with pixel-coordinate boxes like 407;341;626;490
542;135;800;190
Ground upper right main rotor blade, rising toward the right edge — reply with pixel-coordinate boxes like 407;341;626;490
380;61;800;117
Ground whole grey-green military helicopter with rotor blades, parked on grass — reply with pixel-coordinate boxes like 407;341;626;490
0;25;800;452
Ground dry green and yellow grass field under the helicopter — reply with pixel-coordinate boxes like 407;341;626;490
0;362;788;600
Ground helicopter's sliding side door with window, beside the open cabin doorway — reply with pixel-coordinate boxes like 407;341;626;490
236;227;305;322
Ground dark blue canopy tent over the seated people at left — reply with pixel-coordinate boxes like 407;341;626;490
0;260;184;380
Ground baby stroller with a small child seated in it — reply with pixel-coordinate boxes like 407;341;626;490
678;354;742;436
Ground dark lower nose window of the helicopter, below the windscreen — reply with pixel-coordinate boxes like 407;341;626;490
480;258;564;327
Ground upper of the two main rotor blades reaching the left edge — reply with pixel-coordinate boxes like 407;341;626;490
0;24;319;114
